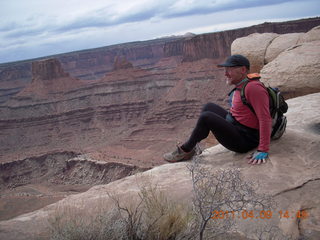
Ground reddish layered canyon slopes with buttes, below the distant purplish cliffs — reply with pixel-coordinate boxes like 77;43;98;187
0;55;228;166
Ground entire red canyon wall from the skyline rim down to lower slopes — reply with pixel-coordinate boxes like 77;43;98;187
0;18;320;167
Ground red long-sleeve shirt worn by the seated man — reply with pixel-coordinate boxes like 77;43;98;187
230;80;272;152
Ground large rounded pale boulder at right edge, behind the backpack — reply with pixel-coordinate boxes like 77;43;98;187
261;41;320;97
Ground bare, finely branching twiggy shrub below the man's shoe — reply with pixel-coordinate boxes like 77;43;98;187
188;156;273;240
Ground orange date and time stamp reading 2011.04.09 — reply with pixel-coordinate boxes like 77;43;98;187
211;210;310;220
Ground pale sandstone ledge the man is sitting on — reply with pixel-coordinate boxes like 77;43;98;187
0;93;320;240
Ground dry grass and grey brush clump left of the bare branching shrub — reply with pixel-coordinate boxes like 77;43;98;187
49;179;192;240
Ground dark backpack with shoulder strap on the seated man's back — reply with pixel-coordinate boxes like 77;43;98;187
240;74;288;140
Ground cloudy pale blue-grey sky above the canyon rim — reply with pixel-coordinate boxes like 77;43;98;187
0;0;320;63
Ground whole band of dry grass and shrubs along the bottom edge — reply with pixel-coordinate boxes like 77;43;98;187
49;156;296;240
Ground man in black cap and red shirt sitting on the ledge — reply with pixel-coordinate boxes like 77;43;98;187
163;55;272;164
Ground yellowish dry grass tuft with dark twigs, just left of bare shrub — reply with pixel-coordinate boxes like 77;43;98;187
107;181;191;240
